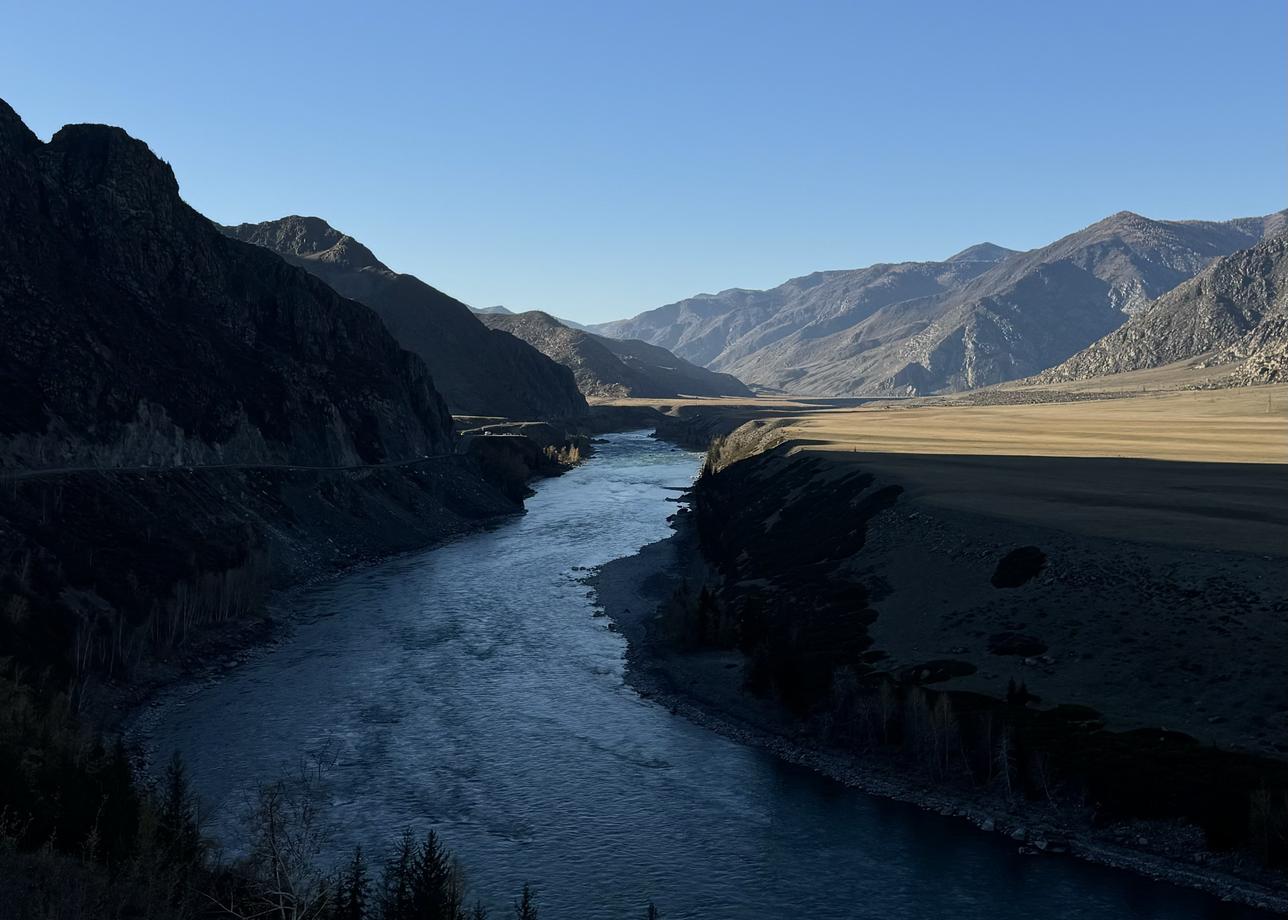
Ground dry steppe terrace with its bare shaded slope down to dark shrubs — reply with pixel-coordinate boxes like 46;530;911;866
602;375;1288;755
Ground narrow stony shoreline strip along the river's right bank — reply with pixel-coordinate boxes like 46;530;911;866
589;492;1288;912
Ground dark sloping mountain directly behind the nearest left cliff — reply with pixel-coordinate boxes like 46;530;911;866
223;216;587;420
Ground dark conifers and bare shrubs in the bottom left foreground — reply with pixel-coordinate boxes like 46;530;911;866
0;678;536;920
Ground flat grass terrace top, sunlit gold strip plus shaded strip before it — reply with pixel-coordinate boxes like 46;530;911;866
600;375;1288;555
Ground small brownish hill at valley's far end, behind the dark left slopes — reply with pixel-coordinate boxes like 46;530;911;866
480;311;751;397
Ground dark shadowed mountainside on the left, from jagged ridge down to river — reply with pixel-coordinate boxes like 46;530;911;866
0;102;519;676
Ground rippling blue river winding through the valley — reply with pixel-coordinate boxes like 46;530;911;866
149;433;1265;920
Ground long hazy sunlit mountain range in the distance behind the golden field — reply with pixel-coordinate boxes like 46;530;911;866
595;211;1284;396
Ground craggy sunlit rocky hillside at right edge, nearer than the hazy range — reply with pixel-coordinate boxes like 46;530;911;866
1034;236;1288;383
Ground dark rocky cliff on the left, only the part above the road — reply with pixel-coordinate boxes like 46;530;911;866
0;103;451;468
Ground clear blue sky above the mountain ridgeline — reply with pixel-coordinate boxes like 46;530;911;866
0;0;1288;321
